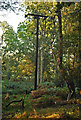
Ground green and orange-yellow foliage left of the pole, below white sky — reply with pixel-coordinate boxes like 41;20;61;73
2;22;35;81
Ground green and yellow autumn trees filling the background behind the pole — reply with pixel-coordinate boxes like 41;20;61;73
0;1;81;119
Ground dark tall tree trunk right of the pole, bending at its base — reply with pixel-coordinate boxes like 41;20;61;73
57;2;75;100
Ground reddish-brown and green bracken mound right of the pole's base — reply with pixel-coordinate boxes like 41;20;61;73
31;82;68;107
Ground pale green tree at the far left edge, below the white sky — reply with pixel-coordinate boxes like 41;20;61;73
2;22;19;79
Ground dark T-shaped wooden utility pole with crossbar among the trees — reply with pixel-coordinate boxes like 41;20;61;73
25;14;48;90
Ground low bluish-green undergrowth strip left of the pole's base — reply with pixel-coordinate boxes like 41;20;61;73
2;81;34;95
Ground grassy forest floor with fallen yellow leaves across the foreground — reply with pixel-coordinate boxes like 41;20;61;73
2;80;80;120
